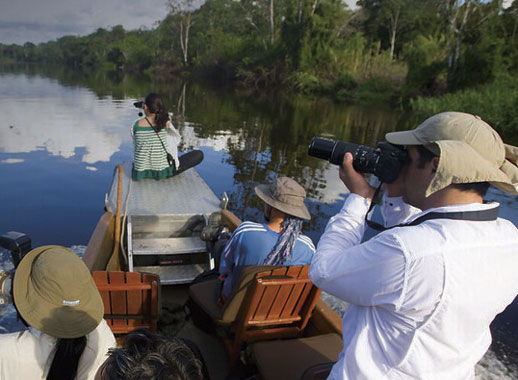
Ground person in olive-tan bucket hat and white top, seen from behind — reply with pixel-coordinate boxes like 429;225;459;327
0;245;116;380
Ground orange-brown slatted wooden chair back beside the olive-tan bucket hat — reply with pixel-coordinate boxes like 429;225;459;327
92;271;160;335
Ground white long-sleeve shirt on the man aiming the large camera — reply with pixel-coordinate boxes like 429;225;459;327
309;194;518;380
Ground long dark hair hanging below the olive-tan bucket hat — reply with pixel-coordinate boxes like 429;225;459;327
47;336;86;380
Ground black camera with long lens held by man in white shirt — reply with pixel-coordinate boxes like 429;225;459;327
308;137;408;183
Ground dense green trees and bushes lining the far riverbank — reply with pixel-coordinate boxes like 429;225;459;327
0;0;518;107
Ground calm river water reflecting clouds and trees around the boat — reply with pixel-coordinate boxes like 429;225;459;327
0;67;518;379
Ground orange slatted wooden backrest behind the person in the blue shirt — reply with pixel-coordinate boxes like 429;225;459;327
229;265;321;365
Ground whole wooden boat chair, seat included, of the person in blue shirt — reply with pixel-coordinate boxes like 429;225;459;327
189;265;321;365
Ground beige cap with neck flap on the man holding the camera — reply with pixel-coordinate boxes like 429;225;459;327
385;112;518;196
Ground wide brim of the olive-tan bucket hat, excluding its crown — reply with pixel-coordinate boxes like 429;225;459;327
13;245;104;339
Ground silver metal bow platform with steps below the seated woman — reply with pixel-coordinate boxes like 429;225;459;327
105;162;221;285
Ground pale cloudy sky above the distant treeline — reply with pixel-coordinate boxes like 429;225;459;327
0;0;356;45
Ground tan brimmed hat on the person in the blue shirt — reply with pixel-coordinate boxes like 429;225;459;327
255;177;311;219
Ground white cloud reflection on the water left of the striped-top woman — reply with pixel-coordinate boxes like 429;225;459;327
0;75;134;164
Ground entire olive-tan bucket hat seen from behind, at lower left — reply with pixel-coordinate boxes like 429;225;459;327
13;245;104;339
